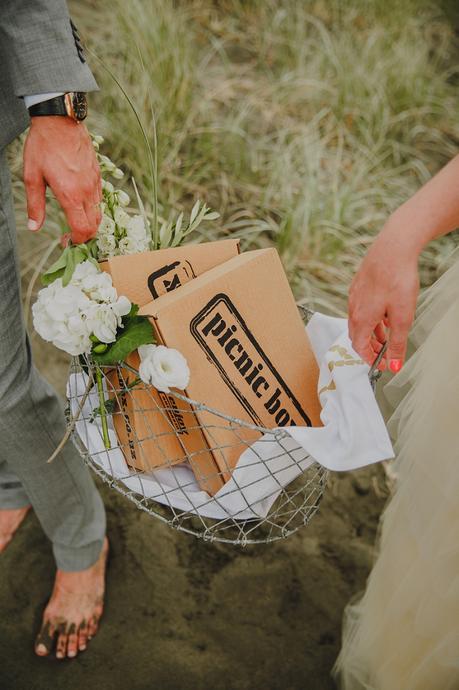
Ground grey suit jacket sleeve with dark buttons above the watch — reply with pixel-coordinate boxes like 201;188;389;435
0;0;98;150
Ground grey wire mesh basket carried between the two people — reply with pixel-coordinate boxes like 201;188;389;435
68;307;382;546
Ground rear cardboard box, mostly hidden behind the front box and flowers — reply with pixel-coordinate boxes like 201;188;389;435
101;240;239;493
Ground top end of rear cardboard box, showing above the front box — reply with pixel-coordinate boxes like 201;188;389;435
101;239;239;307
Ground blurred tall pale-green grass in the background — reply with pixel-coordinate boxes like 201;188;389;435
9;0;459;314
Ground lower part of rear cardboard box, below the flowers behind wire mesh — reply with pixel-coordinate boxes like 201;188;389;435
108;352;223;494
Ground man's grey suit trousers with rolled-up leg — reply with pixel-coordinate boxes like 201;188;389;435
0;150;105;571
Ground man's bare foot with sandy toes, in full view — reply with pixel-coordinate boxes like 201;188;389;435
35;538;108;659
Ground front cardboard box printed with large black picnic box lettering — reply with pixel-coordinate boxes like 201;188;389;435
140;249;321;481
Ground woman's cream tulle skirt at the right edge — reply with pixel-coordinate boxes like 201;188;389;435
334;250;459;690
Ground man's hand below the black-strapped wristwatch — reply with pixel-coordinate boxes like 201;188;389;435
24;115;102;244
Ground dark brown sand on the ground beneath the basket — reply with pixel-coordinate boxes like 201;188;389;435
0;341;385;690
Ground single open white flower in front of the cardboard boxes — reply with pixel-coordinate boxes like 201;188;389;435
139;345;190;393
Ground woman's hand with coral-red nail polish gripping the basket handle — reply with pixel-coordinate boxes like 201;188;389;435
349;216;419;373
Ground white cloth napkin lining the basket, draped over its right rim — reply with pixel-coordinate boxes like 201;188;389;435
67;312;394;520
